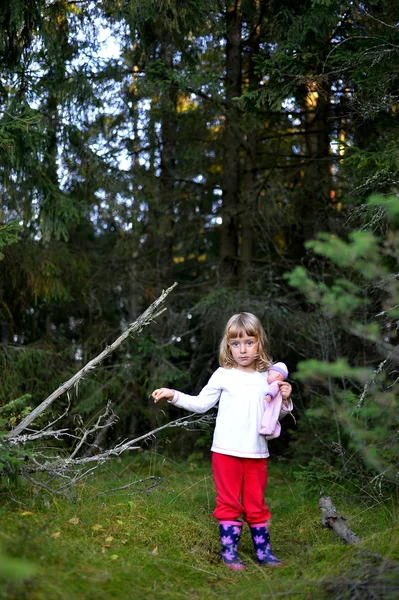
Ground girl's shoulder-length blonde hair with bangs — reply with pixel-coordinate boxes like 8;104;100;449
219;313;272;371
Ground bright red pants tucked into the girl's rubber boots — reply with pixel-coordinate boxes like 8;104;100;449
212;452;271;525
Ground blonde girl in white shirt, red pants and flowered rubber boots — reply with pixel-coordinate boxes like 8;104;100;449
152;312;293;570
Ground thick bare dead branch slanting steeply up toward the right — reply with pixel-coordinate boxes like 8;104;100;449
5;283;177;440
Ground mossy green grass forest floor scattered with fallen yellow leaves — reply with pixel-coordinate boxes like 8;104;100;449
0;452;399;600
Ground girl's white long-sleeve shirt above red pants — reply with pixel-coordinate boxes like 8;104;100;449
171;367;292;458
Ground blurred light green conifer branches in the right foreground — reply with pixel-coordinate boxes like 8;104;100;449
289;197;399;492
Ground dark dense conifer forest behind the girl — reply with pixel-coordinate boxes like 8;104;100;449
0;0;399;492
